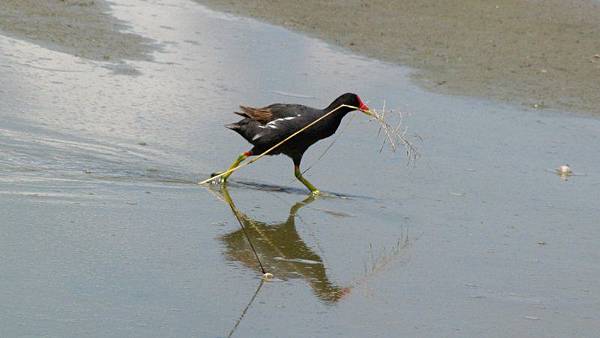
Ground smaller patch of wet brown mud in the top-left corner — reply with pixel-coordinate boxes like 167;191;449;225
0;0;155;62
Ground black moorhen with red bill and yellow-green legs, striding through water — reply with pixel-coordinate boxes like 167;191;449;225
216;93;370;194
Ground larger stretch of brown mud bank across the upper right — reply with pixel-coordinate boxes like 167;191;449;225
200;0;600;113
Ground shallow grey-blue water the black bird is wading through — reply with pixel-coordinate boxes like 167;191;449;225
0;1;600;337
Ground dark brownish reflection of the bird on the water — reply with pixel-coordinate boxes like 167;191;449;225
220;186;350;303
